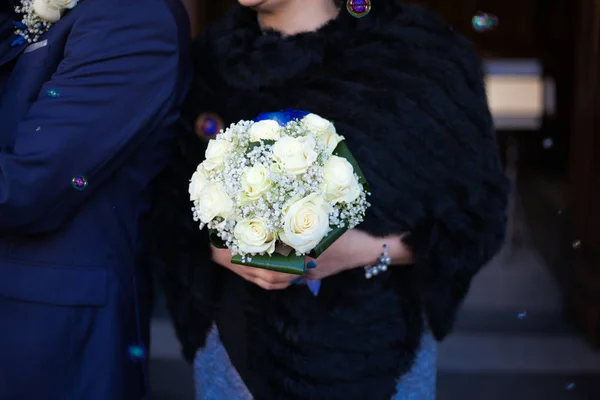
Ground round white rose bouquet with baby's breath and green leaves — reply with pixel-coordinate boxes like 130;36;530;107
189;110;369;275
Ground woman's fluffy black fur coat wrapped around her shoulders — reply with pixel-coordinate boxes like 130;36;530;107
152;0;508;400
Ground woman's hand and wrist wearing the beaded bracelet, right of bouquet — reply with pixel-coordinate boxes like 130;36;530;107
306;229;412;280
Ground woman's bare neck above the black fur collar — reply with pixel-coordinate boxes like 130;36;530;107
258;0;339;36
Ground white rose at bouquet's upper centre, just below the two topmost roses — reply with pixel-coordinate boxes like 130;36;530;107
273;136;318;175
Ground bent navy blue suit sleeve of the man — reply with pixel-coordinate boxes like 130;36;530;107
0;2;179;234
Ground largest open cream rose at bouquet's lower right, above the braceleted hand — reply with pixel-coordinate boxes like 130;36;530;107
279;193;331;253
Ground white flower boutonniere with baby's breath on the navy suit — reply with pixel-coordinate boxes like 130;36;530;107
13;0;79;45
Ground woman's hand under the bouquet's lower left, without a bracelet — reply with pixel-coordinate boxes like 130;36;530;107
211;245;298;290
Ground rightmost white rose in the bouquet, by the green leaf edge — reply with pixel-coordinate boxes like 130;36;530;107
323;156;361;203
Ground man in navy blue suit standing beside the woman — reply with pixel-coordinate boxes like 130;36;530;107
0;0;191;400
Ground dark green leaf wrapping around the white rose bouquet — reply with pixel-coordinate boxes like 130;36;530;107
209;141;369;275
